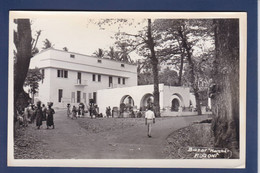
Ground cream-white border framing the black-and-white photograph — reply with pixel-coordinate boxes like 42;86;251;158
7;11;247;168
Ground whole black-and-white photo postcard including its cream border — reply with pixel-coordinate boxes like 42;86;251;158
7;11;247;168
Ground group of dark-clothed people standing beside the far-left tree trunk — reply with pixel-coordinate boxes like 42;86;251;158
17;101;55;129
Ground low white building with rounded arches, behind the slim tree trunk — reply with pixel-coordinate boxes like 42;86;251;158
97;84;194;115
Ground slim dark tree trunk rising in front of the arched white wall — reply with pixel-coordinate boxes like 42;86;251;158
147;19;160;117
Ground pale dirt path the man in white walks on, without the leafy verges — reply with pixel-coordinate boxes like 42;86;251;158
31;111;208;159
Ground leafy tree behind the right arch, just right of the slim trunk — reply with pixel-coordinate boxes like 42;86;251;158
155;19;214;114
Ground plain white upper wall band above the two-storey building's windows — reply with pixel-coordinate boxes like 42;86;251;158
30;49;137;86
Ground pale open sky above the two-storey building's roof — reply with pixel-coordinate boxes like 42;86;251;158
27;16;142;60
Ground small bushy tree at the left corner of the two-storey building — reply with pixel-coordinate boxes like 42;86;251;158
24;68;43;102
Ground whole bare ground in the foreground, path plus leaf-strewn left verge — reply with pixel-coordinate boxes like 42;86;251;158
14;111;208;159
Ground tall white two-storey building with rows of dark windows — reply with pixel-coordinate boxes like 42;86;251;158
30;48;137;108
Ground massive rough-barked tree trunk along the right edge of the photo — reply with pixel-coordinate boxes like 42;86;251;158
211;19;239;158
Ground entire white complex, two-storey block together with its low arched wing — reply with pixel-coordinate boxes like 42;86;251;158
30;49;209;116
